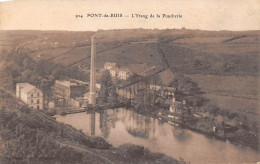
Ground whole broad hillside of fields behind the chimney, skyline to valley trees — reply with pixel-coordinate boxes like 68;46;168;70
0;29;260;118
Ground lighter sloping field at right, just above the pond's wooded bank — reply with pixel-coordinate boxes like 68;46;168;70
186;74;260;118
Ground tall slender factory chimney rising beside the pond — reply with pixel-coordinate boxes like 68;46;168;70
89;36;96;106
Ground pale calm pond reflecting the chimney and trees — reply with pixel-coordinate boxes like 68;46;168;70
57;109;260;164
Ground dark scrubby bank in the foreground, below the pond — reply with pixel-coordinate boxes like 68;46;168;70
0;90;179;163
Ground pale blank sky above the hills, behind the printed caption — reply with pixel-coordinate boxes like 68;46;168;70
0;0;260;31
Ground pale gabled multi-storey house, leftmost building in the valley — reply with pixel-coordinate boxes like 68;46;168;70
16;83;43;110
